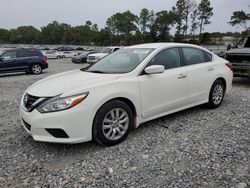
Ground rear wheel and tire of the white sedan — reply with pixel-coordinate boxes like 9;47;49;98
208;80;225;109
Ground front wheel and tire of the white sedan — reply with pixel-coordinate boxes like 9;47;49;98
92;100;134;146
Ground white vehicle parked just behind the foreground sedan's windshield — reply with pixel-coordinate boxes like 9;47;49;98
87;47;121;63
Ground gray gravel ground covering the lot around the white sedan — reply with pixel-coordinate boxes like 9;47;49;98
0;60;250;188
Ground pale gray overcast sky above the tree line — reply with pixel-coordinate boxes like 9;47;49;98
0;0;250;32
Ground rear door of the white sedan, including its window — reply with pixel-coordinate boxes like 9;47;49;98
182;47;215;104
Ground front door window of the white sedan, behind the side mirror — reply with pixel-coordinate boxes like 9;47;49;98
148;48;181;69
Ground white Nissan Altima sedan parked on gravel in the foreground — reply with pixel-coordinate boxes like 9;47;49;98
20;43;233;145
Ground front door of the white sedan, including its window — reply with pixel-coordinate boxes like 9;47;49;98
139;48;188;119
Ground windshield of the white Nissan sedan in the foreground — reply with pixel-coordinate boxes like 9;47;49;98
86;48;153;74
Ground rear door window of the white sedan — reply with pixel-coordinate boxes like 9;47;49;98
182;48;206;65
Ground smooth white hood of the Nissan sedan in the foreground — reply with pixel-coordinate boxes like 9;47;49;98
27;70;118;97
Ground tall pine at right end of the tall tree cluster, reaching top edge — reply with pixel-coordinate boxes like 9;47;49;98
198;0;213;34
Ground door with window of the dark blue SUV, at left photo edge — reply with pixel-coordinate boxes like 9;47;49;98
0;51;18;72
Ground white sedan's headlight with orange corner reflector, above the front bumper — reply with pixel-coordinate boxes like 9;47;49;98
37;92;89;113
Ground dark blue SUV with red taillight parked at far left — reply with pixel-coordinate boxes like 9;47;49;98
0;49;48;74
